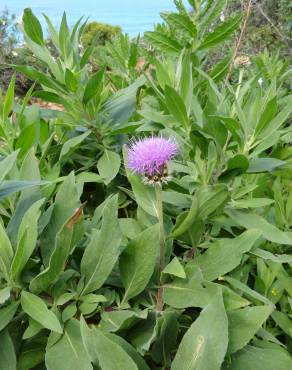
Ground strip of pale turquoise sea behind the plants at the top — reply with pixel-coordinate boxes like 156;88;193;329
0;0;187;36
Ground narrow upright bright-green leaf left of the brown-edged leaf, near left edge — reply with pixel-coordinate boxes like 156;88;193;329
10;199;44;281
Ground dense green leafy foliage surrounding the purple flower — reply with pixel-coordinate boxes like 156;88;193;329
0;0;292;370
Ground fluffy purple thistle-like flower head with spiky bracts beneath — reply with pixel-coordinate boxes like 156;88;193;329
128;136;178;185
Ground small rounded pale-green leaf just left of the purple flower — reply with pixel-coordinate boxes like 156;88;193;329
97;150;121;185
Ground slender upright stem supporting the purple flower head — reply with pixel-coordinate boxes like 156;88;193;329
155;185;165;311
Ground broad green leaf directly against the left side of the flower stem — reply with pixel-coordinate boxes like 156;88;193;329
120;225;159;302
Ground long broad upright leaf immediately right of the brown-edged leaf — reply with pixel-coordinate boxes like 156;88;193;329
81;195;121;294
